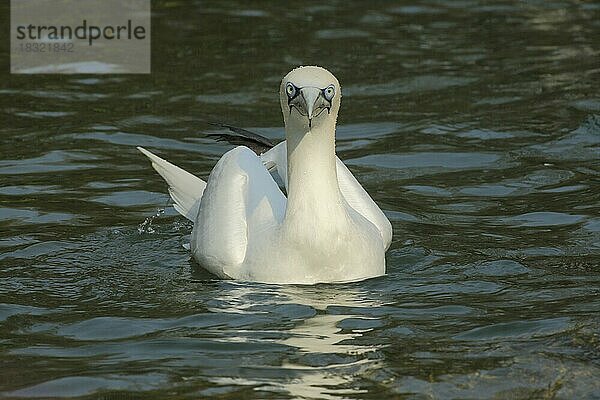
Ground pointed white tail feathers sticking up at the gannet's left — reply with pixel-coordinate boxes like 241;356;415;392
137;147;206;222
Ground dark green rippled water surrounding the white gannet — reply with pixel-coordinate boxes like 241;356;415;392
0;0;600;399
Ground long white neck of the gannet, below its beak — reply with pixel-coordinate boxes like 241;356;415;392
286;118;343;220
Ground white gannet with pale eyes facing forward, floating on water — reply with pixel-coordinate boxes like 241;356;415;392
138;66;392;284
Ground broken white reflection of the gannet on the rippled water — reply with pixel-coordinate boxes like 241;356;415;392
199;282;382;399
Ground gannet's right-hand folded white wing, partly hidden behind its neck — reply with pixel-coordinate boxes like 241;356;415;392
260;141;392;249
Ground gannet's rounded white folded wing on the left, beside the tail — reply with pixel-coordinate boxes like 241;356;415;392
191;146;286;278
